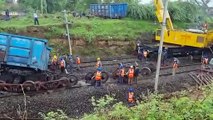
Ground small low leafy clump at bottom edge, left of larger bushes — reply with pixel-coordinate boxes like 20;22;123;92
39;110;68;120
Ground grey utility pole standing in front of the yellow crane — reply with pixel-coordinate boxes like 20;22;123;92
155;0;168;92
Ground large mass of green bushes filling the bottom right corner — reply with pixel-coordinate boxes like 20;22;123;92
83;85;213;120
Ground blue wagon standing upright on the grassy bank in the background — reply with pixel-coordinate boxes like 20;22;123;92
90;3;128;18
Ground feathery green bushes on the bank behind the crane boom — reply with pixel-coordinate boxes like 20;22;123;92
128;0;206;22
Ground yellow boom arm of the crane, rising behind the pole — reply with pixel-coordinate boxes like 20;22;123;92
155;0;174;30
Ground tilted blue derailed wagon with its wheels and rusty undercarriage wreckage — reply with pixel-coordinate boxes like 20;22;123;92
0;33;76;92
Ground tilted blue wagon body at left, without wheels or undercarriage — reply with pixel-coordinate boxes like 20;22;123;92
0;33;51;71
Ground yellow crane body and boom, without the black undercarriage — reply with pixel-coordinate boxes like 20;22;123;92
155;0;213;48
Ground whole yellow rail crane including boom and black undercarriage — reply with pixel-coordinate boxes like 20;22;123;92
136;0;213;57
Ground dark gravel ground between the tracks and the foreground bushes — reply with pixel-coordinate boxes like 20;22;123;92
0;71;196;118
